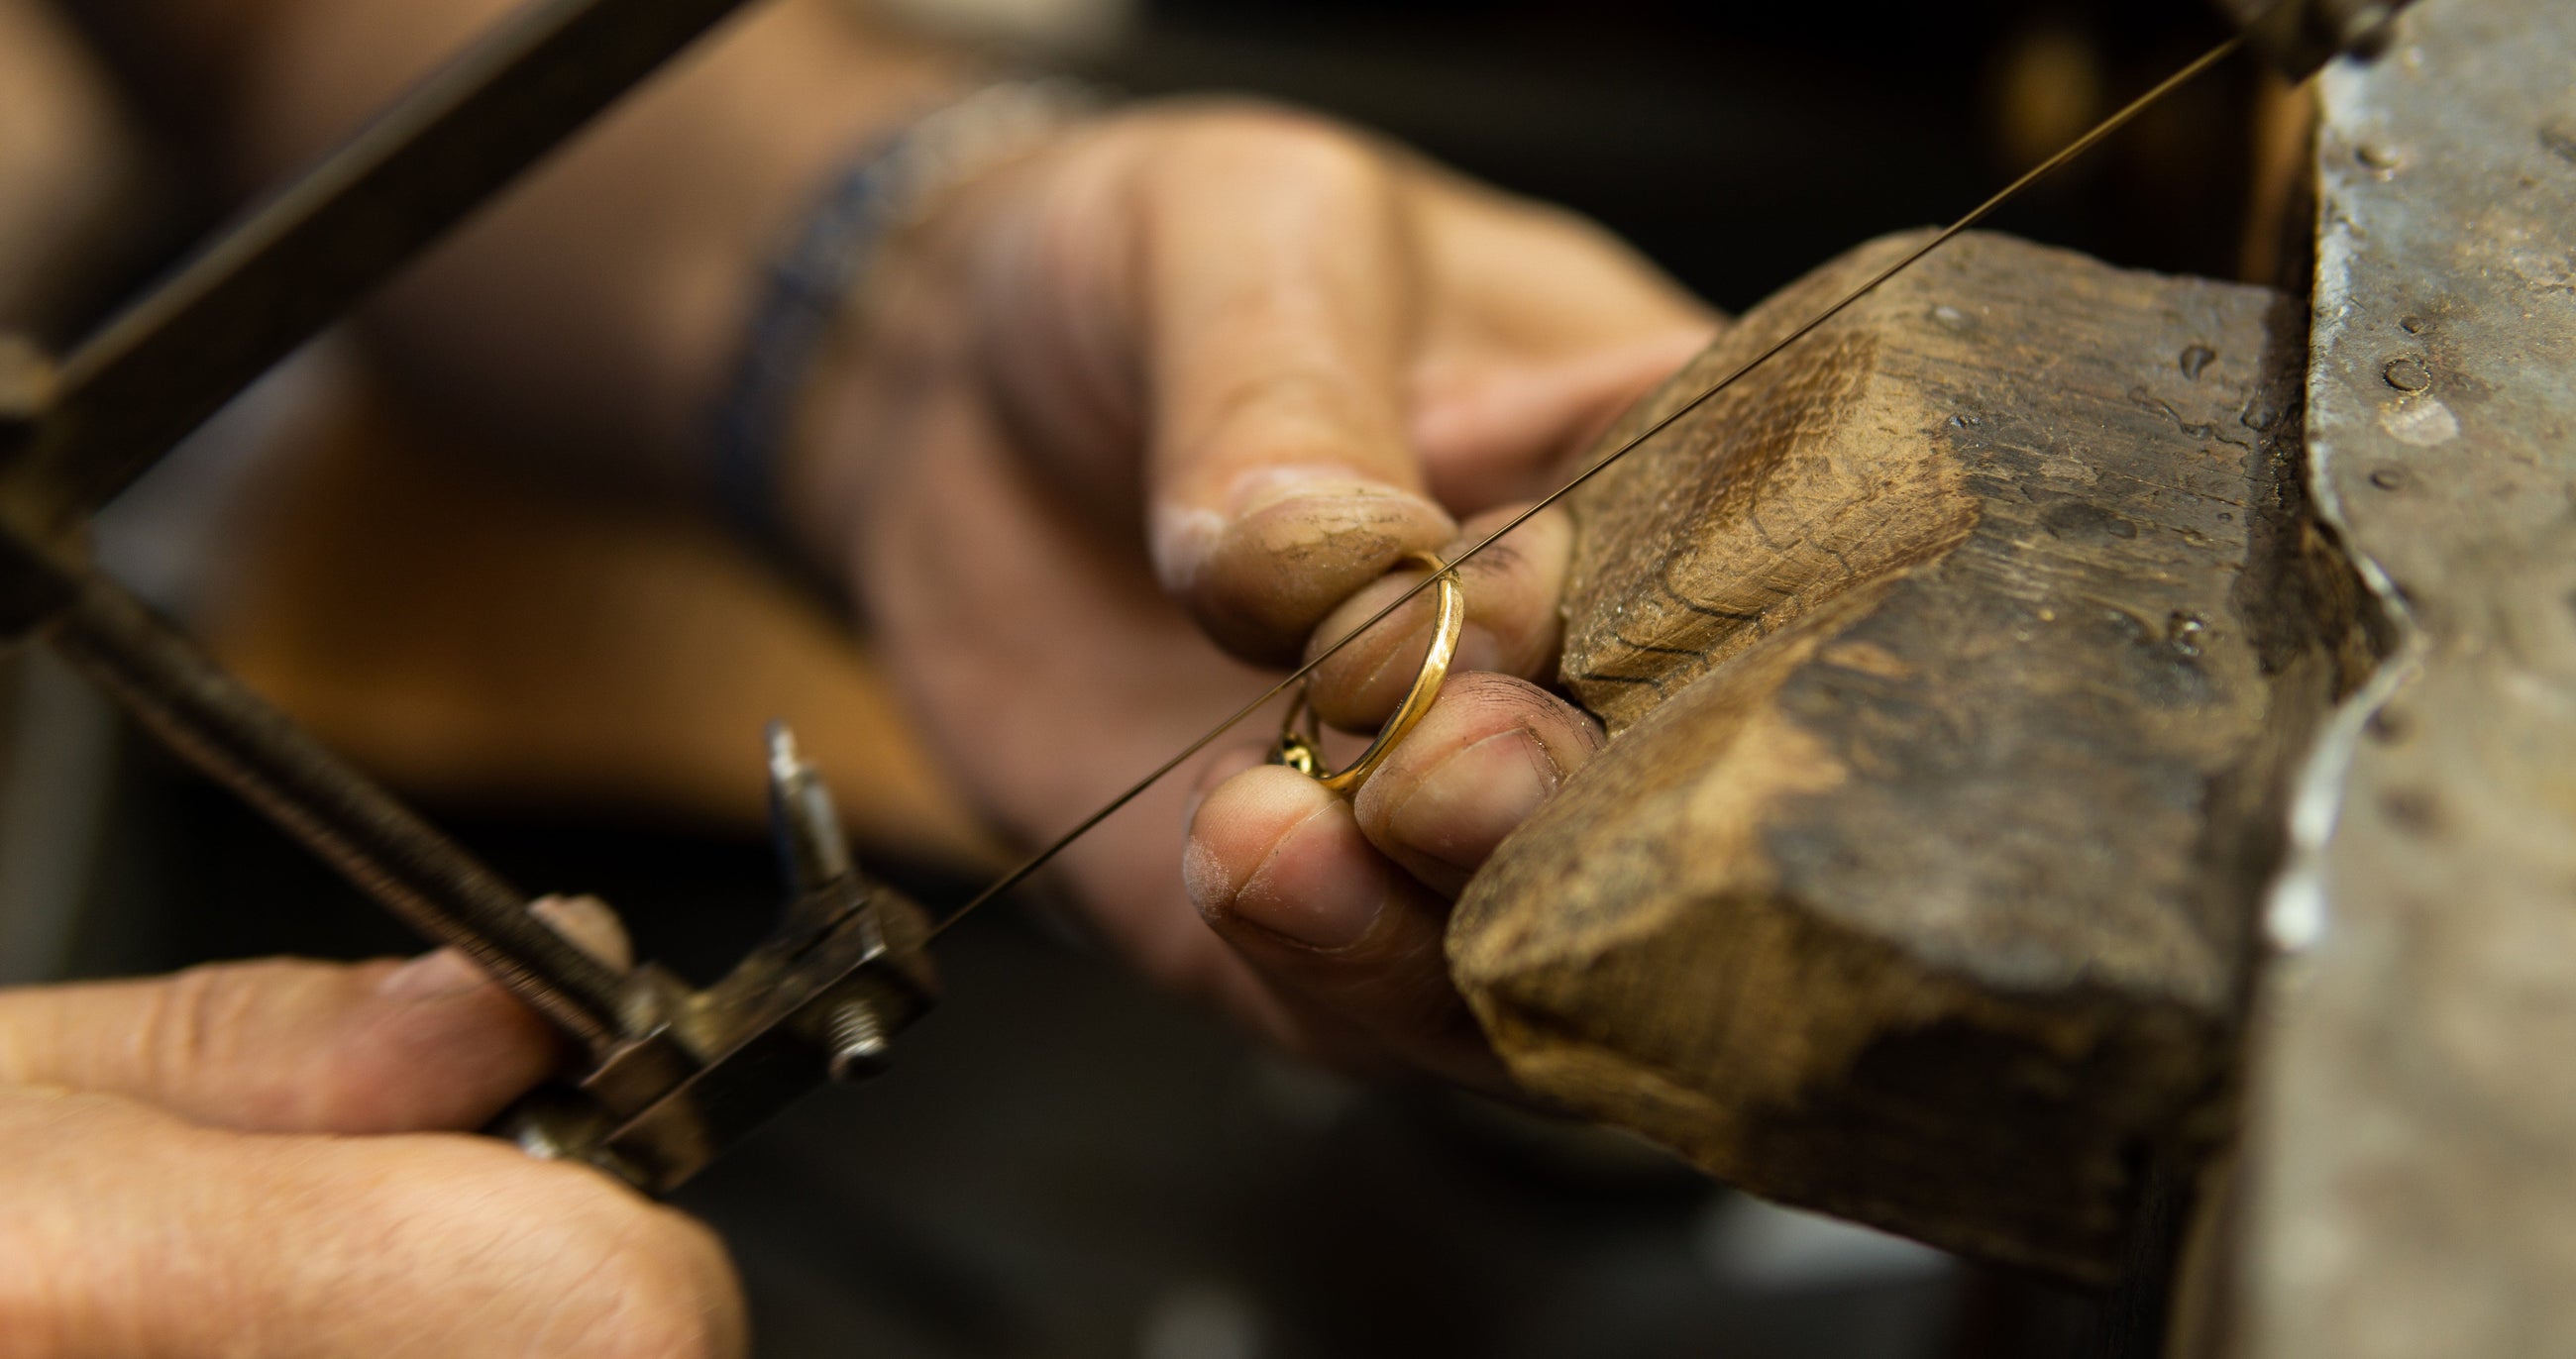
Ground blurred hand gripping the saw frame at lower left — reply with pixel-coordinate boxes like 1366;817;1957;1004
0;900;744;1359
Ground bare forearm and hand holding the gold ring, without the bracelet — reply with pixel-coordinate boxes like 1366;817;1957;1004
146;0;1718;1084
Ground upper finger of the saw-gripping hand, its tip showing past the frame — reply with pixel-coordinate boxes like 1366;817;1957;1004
0;898;623;1132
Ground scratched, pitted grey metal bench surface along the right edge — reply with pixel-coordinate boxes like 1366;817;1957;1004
2236;0;2576;1359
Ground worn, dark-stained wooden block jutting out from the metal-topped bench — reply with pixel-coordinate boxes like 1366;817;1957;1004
1450;234;2336;1277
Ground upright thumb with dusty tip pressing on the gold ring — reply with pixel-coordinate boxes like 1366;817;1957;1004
1133;108;1455;662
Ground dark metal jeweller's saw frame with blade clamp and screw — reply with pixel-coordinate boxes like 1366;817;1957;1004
0;0;2404;1192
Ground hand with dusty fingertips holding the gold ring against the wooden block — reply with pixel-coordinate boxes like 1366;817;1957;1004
789;103;1716;1084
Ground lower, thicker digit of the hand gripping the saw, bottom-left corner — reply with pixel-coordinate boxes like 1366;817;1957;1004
0;1089;744;1359
